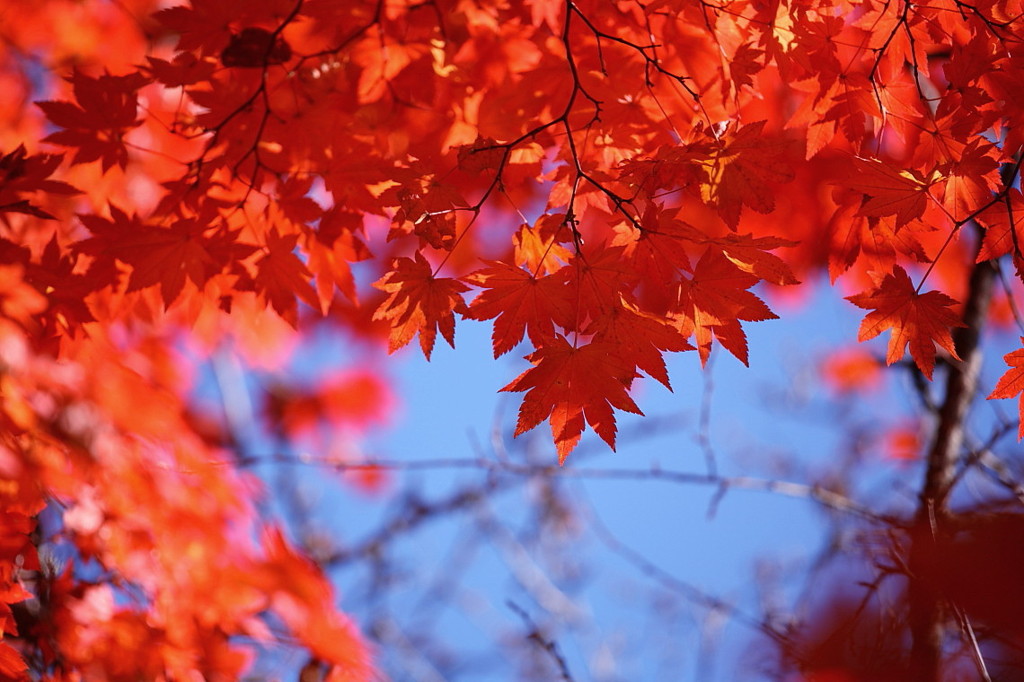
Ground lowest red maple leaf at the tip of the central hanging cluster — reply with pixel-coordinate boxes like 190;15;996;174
502;335;643;464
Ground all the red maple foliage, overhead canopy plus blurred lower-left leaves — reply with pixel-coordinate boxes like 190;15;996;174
0;0;1024;680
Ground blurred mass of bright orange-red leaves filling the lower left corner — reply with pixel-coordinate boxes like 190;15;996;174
0;315;370;680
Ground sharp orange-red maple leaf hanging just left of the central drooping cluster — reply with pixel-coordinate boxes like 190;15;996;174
374;251;469;359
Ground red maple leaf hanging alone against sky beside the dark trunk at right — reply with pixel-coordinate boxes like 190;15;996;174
847;265;964;379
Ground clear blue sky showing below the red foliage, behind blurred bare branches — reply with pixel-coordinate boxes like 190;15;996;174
211;268;1016;682
